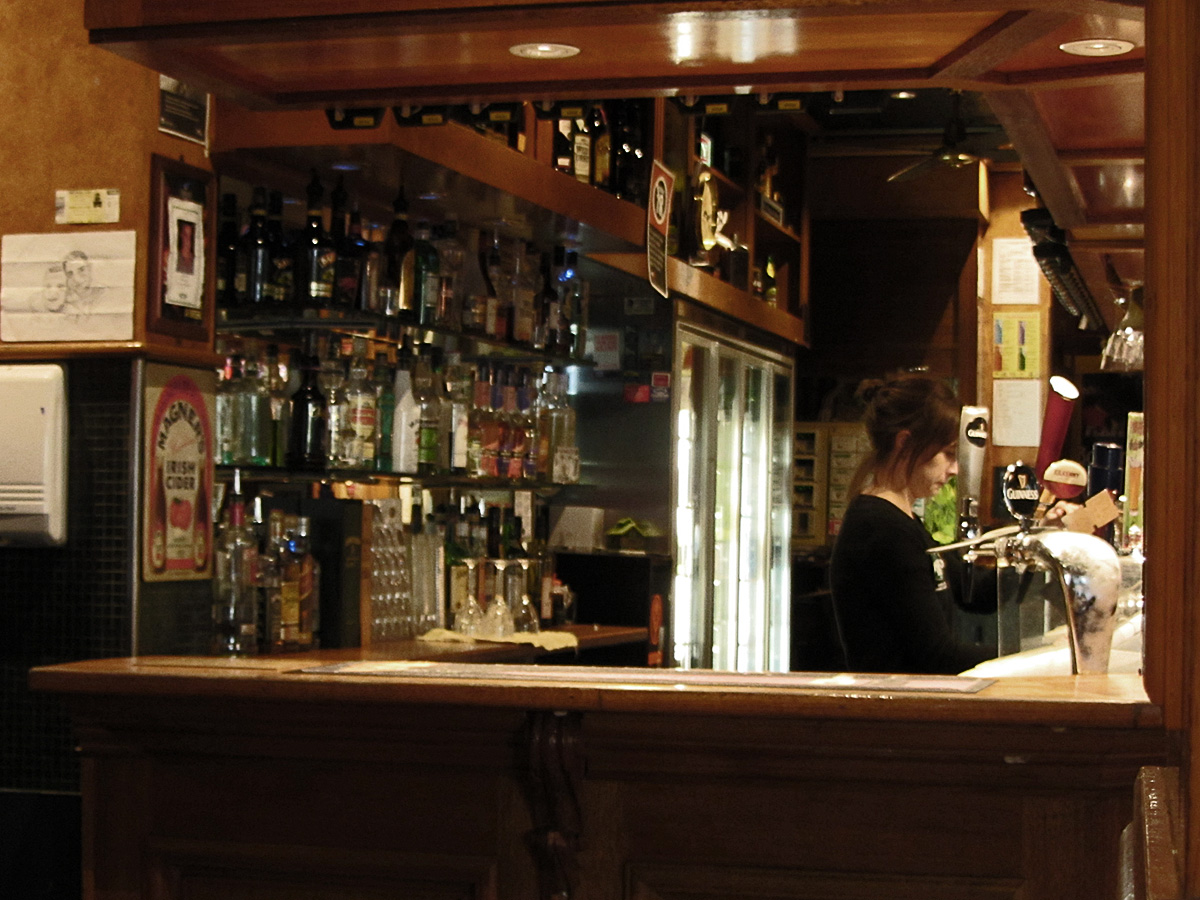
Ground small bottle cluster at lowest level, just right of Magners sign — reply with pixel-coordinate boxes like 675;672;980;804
212;469;320;656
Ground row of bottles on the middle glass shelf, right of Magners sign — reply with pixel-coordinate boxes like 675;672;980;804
216;337;578;484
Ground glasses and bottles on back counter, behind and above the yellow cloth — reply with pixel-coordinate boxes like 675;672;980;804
370;497;574;642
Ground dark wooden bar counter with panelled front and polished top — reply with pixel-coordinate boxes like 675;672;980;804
31;652;1176;900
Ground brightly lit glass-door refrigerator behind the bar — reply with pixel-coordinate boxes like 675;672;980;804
671;323;793;672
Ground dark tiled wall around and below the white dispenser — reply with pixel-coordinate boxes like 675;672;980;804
0;360;137;792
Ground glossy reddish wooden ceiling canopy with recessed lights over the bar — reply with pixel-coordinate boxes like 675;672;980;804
85;0;1145;325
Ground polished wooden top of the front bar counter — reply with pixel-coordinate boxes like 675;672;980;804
30;625;1163;730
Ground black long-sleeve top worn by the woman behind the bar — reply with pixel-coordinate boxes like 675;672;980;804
829;494;995;674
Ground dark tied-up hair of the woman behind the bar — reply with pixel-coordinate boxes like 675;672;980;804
850;373;961;497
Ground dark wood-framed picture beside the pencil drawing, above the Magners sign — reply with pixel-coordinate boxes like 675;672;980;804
146;154;216;341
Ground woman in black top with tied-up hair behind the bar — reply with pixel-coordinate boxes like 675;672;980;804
830;374;995;674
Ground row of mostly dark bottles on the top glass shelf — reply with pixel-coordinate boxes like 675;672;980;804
217;173;589;358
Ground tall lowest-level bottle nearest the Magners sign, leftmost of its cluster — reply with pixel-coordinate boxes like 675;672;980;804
212;469;259;656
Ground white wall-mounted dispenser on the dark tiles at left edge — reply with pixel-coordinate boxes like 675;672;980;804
0;364;67;546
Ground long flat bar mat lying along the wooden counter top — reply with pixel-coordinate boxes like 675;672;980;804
300;660;996;694
